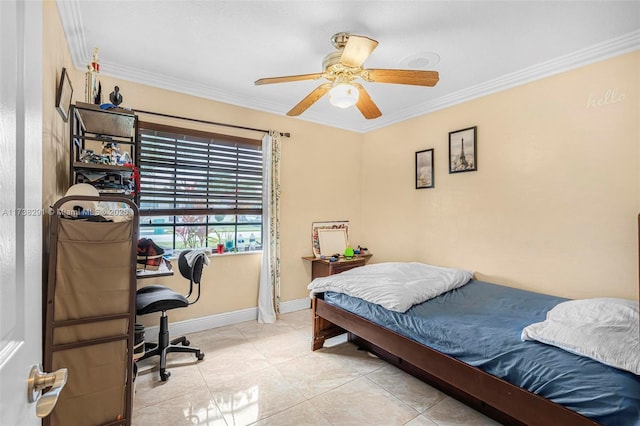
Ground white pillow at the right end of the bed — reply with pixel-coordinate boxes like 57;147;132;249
521;298;640;375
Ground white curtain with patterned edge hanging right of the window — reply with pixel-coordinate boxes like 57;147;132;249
258;130;280;323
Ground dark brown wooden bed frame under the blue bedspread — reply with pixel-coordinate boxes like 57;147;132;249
311;214;640;426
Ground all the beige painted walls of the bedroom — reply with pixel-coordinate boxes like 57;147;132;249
43;0;640;325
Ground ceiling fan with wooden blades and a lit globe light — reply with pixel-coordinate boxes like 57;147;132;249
255;32;439;119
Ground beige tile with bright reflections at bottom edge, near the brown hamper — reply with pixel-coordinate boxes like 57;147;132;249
131;388;226;426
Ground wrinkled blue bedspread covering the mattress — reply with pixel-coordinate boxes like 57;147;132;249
325;281;640;426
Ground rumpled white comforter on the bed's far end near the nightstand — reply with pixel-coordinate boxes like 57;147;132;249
307;262;473;312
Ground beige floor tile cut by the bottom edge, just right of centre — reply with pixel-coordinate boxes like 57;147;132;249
310;377;420;426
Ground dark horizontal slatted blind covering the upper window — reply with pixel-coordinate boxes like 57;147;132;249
139;122;263;216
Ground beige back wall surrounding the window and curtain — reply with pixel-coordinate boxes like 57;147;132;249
90;75;362;326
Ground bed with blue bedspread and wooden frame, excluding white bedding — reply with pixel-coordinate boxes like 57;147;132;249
310;223;640;426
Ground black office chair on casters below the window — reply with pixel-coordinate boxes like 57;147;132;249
136;250;206;381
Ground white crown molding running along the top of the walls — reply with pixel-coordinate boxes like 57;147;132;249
57;0;640;133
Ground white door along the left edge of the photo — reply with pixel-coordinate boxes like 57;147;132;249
0;0;43;426
